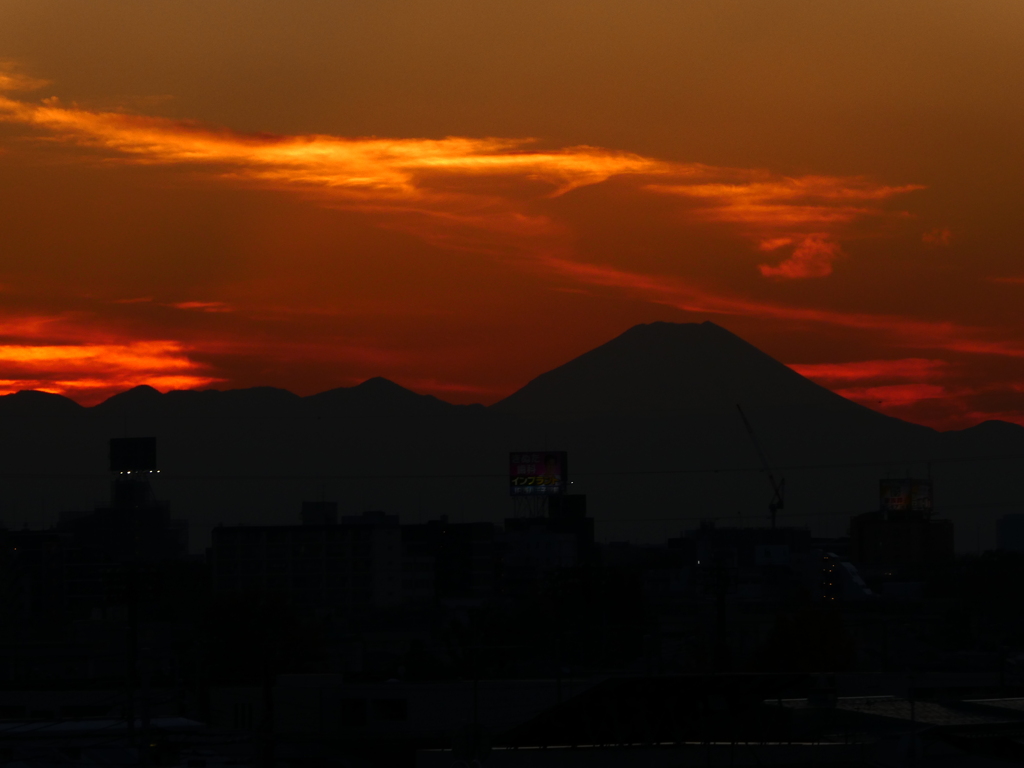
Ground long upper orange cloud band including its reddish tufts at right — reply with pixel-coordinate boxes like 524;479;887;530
0;75;922;279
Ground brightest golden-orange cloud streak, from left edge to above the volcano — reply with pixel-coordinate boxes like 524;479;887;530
0;90;664;203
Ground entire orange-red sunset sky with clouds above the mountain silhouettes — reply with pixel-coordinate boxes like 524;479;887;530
0;0;1024;429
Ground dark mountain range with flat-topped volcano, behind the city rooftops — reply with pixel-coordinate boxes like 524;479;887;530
0;323;1024;550
